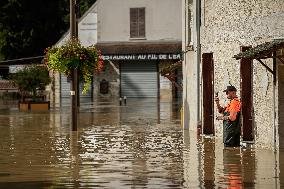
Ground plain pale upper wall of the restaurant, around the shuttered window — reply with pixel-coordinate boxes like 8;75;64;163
98;0;181;42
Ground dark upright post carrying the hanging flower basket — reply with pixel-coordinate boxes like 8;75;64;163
70;0;78;131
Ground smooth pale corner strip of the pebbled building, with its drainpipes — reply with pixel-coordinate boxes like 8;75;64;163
183;0;201;130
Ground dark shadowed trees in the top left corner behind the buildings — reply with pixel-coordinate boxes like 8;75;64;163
0;0;96;60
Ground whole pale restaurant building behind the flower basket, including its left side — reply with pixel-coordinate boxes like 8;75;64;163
51;0;182;102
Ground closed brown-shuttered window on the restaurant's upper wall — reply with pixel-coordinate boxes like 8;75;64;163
130;8;145;38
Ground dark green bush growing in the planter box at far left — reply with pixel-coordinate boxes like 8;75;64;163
10;65;51;99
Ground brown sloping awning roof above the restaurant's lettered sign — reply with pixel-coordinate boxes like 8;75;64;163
96;41;182;55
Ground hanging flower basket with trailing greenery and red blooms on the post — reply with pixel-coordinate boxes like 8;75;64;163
45;39;103;94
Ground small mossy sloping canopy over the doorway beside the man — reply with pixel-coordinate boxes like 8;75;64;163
233;39;284;60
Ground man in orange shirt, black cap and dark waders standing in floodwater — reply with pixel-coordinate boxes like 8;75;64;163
215;85;241;147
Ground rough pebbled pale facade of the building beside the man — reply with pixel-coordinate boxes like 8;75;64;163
183;0;284;148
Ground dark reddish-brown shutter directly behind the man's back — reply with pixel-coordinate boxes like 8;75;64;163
240;46;254;141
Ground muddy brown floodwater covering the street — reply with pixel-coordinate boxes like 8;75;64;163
0;99;281;189
